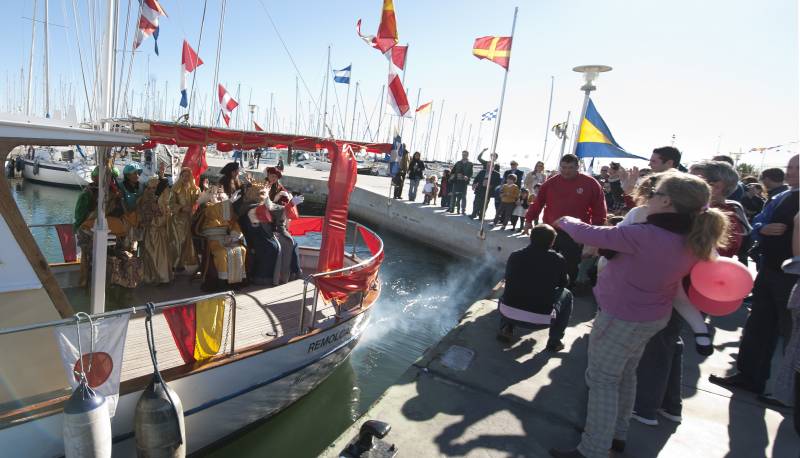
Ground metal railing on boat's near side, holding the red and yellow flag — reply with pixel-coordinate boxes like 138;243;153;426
0;291;236;354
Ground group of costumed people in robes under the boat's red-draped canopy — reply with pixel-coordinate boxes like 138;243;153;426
73;157;303;291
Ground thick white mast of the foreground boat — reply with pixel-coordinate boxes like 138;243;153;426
91;0;117;314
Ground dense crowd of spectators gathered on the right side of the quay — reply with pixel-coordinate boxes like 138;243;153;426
472;147;800;457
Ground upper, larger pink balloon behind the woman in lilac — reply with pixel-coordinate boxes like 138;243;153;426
690;257;753;302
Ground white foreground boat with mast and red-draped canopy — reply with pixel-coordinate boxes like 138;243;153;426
0;1;390;457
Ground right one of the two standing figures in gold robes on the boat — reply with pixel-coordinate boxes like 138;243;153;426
169;167;200;272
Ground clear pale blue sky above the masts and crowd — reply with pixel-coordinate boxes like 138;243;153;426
0;0;798;166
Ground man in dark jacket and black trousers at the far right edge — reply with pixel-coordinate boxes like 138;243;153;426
708;156;800;394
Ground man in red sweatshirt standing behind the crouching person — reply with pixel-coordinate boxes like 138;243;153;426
525;154;606;286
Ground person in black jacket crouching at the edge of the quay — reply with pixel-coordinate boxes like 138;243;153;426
497;224;572;352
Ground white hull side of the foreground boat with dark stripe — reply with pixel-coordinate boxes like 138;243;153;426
0;309;370;457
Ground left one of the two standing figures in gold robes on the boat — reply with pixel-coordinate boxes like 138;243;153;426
138;177;173;284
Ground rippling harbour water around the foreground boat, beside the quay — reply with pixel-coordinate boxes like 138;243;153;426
13;183;496;457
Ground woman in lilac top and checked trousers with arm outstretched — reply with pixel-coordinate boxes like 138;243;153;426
550;173;728;458
